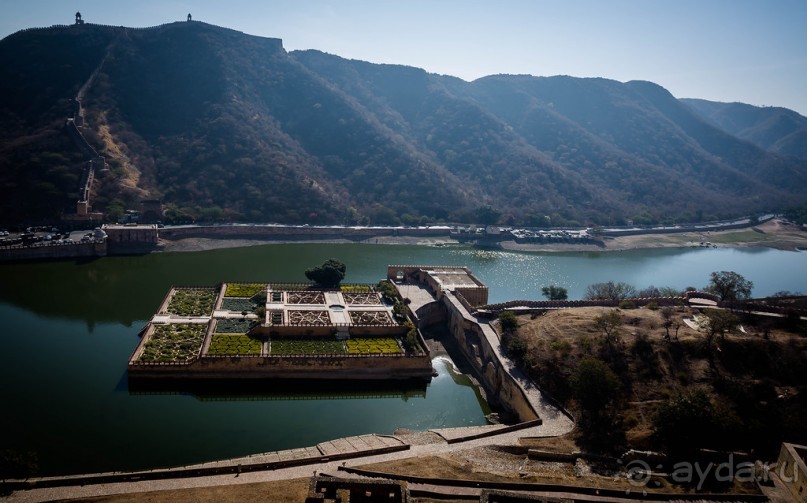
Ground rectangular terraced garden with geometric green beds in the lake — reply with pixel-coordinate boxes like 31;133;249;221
129;274;433;379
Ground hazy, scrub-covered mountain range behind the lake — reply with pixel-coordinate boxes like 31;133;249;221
0;22;807;225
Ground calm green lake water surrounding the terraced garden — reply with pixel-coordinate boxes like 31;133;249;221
0;244;807;474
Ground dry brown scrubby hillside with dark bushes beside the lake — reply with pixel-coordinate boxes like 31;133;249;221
504;307;807;456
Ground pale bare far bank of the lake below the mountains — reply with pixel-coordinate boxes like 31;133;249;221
150;220;807;253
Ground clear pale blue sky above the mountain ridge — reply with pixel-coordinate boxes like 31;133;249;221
6;0;807;115
